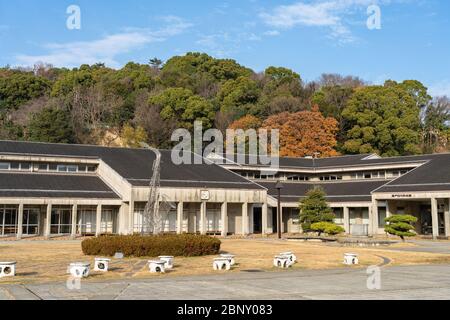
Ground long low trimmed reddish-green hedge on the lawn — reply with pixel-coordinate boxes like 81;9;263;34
81;234;221;257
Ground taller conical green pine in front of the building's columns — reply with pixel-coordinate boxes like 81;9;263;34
299;187;335;232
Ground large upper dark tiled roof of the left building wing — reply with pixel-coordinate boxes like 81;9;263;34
0;141;261;189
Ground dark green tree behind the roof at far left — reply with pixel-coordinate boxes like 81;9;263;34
28;107;74;143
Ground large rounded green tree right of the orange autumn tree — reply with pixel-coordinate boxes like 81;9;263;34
342;85;420;156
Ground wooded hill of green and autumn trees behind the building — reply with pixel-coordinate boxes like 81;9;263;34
0;53;450;157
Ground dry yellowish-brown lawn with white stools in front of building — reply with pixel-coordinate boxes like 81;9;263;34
0;239;450;285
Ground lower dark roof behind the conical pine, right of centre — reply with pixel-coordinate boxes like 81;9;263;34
260;181;386;202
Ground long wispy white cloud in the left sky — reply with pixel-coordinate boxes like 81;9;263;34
16;16;191;67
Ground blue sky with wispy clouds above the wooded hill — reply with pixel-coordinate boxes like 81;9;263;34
0;0;450;96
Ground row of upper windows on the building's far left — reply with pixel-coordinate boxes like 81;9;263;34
0;162;97;173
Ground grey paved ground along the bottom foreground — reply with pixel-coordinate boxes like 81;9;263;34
0;265;450;300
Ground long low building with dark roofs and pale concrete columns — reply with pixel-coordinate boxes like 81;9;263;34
0;141;450;239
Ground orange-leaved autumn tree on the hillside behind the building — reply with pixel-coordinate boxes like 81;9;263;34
262;105;339;158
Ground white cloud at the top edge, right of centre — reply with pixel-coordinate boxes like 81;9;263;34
260;0;394;42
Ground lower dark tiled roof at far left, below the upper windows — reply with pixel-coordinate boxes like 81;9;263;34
0;173;119;199
